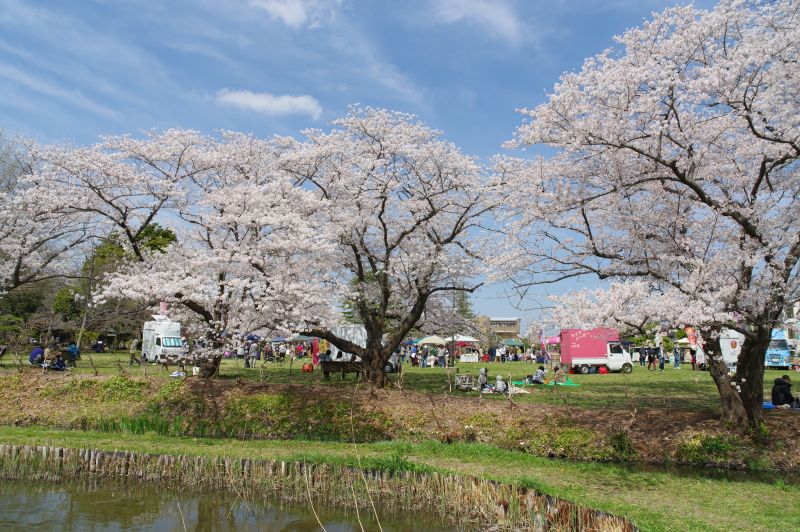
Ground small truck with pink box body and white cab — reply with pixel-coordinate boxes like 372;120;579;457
561;327;633;373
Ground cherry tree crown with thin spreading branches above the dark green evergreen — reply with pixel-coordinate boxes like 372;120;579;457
29;129;216;261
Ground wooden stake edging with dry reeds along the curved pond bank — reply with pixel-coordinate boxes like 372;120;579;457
0;445;638;532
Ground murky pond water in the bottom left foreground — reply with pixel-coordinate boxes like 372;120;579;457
0;480;452;532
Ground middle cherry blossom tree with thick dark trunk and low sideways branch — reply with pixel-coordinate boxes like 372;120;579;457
277;107;491;387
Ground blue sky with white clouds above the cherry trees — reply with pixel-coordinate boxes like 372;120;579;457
0;0;712;332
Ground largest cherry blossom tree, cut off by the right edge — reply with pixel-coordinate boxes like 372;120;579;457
501;0;800;429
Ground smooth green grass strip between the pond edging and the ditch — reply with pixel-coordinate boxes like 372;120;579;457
0;427;800;530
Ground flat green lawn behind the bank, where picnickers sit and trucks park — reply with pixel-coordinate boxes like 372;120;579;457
7;352;784;413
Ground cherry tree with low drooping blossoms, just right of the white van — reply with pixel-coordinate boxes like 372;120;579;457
96;132;334;377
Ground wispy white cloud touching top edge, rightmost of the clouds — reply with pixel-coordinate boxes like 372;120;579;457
433;0;524;46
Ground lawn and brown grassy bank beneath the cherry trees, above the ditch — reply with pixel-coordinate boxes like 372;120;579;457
0;354;800;470
